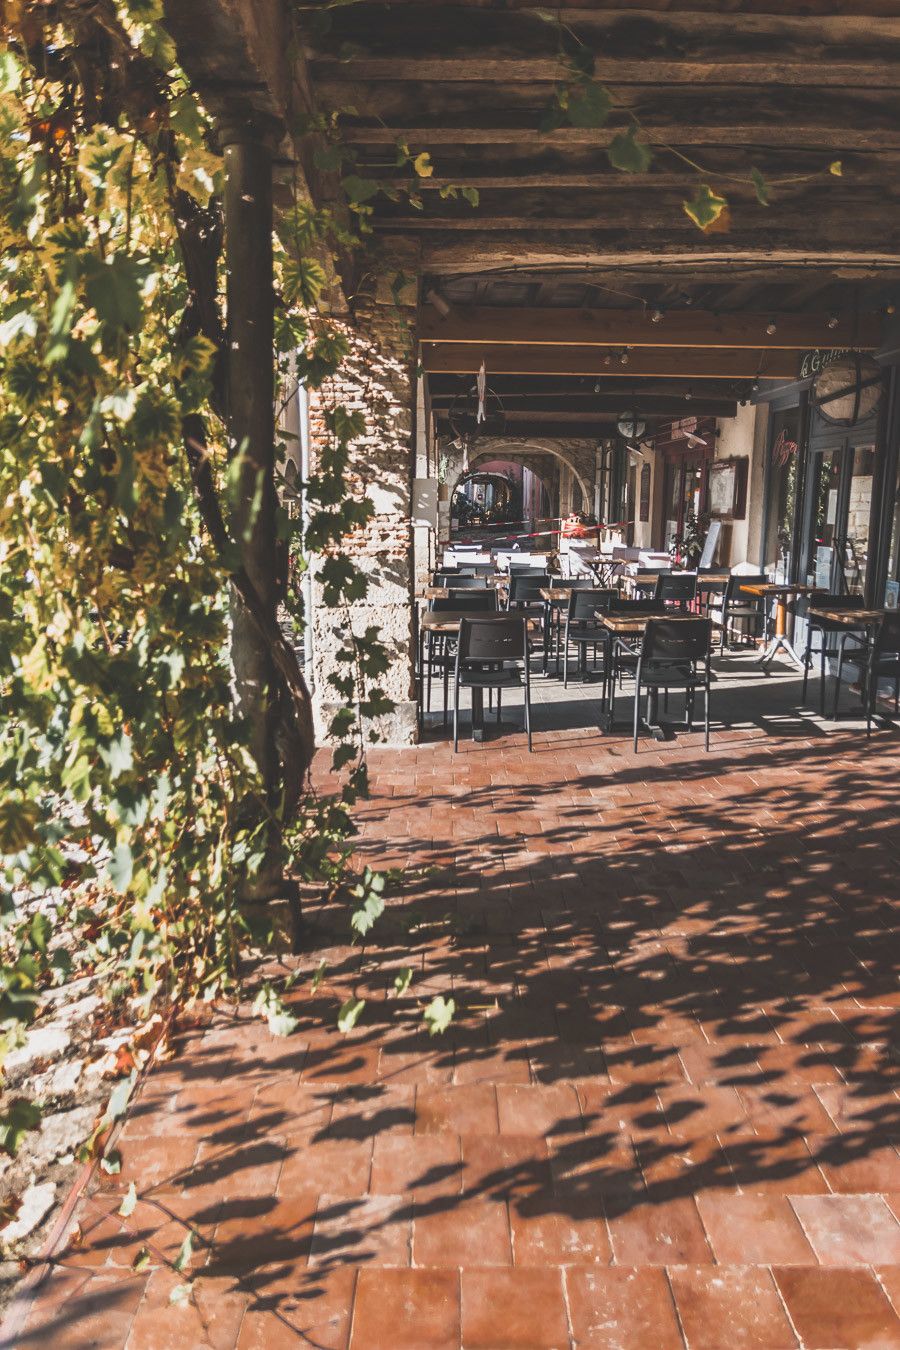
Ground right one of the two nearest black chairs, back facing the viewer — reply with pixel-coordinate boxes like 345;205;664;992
626;617;712;752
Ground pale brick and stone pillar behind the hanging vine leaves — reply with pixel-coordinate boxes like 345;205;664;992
309;250;417;745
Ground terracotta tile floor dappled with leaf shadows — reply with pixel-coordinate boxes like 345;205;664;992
18;660;900;1350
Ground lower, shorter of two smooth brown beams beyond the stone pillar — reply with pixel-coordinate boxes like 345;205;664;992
421;342;800;381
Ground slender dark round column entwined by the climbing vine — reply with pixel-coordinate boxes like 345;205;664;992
219;116;281;899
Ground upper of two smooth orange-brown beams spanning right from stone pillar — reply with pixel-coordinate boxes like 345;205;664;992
418;306;881;351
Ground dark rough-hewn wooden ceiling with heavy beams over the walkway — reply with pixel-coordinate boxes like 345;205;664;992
306;0;900;435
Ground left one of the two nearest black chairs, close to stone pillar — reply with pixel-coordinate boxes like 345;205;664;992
453;614;532;751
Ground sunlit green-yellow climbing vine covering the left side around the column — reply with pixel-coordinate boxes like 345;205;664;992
0;0;444;1152
